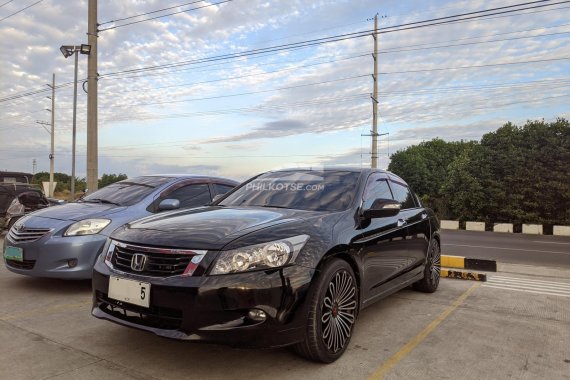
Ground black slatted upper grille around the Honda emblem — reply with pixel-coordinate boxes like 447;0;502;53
111;245;195;277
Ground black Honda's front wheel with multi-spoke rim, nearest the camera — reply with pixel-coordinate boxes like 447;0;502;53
293;259;359;363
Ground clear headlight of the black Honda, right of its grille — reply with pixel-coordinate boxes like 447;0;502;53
210;235;309;274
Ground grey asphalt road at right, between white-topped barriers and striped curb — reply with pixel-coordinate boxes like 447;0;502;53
441;230;570;268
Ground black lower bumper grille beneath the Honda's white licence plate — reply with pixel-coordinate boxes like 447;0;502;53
97;291;182;330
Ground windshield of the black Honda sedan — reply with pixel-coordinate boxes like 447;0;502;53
218;170;360;211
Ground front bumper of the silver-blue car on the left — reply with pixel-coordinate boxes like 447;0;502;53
4;234;107;280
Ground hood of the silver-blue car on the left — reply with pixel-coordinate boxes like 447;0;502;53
27;202;126;221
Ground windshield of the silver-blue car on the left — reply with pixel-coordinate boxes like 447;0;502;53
81;177;172;206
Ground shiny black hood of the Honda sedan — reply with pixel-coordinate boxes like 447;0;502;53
111;206;326;250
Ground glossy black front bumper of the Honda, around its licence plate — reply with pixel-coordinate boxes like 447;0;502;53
92;260;314;348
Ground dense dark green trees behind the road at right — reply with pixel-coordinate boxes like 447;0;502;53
388;118;570;225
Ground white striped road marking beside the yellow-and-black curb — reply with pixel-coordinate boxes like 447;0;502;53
482;276;570;297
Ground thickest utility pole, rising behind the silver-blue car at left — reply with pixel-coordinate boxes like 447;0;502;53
87;0;98;193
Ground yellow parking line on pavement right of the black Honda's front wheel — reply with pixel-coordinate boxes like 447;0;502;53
368;283;480;380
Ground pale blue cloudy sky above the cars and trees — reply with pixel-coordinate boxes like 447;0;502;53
0;0;570;180
